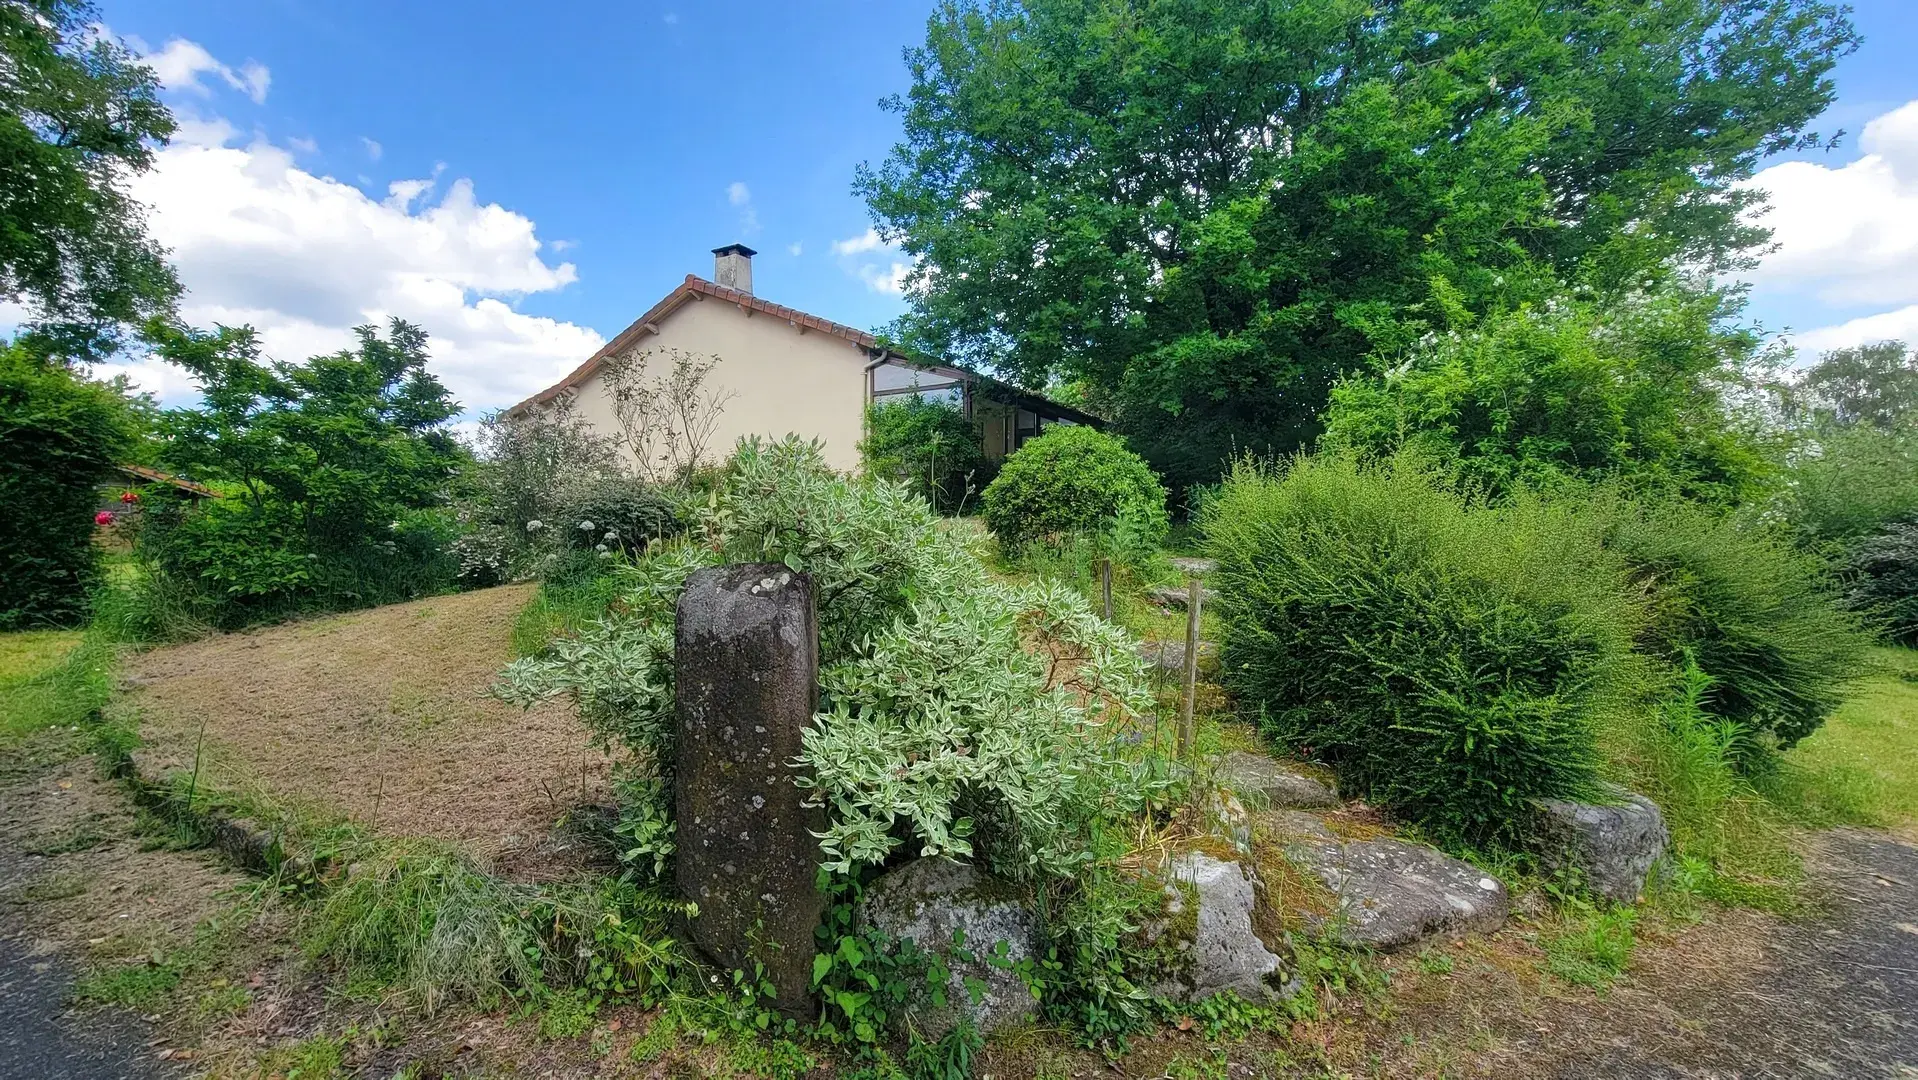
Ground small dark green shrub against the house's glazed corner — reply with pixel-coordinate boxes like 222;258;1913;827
859;397;992;514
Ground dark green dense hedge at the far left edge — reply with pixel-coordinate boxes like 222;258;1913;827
0;345;138;629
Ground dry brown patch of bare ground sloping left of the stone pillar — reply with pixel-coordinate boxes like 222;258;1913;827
123;585;612;879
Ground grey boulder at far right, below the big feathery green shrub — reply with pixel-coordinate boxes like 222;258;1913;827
1532;787;1671;904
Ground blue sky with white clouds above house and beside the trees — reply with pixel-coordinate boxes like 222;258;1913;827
86;0;1918;407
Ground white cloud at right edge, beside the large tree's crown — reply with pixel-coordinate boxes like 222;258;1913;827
1749;102;1918;307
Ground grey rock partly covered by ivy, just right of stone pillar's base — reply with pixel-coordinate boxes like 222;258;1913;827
857;859;1040;1042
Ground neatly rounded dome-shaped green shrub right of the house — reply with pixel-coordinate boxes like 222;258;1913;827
980;426;1166;551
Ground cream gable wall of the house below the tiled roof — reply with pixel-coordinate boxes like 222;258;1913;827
560;293;867;472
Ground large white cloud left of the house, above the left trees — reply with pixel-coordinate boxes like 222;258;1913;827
119;85;604;409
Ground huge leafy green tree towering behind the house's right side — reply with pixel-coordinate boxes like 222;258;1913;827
857;0;1857;481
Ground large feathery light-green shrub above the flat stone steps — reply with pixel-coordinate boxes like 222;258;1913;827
1203;457;1648;840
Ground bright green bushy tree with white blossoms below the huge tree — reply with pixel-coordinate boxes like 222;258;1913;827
1322;290;1776;506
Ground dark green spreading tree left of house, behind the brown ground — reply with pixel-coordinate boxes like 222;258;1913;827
153;318;470;625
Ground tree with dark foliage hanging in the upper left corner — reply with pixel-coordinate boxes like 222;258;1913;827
0;0;180;357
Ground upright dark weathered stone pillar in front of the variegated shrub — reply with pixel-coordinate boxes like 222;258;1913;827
673;562;825;1019
